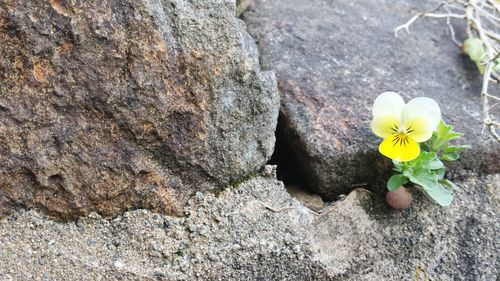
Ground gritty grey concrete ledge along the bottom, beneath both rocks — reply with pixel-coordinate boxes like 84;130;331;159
0;167;500;280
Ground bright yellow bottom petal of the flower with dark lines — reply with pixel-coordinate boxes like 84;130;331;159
378;134;420;162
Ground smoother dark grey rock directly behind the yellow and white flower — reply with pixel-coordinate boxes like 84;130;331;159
243;0;500;199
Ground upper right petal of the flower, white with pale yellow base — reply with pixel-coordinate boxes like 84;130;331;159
402;97;441;142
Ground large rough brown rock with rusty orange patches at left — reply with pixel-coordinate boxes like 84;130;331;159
0;0;279;218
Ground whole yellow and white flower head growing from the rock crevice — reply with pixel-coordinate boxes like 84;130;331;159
371;92;441;161
